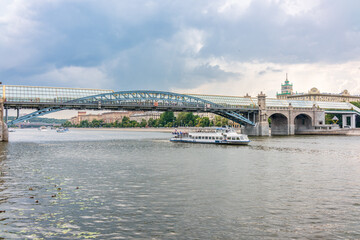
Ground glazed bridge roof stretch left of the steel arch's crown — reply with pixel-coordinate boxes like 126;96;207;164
0;85;113;102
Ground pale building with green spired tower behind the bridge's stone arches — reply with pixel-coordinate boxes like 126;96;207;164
276;76;360;102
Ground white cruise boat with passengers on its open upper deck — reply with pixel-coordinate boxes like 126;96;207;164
170;127;250;145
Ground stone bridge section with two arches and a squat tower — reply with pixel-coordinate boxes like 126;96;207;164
243;93;325;136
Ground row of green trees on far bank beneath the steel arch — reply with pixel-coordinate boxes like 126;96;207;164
62;112;229;128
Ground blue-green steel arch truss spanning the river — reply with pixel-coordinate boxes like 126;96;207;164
4;90;258;126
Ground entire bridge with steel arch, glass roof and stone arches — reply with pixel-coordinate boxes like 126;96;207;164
0;85;360;141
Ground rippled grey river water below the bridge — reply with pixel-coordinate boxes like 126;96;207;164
0;130;360;239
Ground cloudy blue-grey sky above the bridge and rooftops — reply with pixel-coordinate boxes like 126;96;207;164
0;0;360;100
